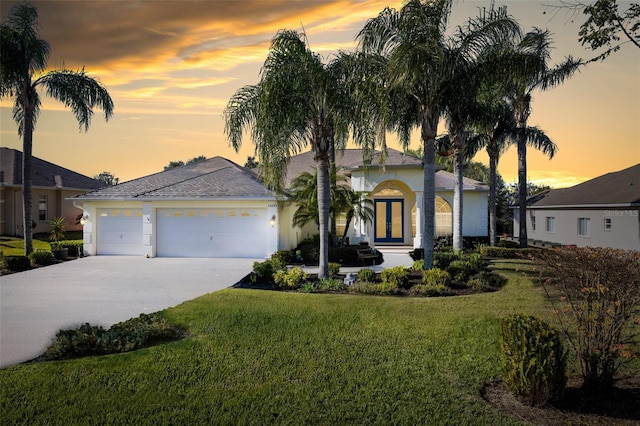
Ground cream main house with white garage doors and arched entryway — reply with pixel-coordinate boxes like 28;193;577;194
72;150;488;258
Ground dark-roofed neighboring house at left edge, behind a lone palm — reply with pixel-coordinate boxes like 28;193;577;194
0;147;104;235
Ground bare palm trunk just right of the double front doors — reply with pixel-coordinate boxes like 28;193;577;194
421;108;439;269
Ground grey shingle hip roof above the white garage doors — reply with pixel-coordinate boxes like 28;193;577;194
74;157;276;200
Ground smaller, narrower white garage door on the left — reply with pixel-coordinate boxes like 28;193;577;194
96;209;142;256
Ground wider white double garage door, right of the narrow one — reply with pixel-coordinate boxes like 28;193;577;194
156;208;269;259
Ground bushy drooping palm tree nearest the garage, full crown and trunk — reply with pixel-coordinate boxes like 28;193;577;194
224;30;358;278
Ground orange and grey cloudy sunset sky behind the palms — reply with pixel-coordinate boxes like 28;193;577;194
0;0;640;188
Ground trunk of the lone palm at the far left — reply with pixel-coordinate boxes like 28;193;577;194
22;107;33;256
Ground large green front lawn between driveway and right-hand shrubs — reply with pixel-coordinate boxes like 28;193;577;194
0;262;560;425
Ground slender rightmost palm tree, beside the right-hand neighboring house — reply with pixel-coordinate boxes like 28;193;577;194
503;28;583;247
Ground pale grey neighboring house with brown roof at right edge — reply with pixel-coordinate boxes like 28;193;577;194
513;164;640;250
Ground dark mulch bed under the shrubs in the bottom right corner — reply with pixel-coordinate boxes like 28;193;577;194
481;375;640;426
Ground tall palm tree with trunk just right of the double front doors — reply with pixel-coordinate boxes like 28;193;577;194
357;0;520;269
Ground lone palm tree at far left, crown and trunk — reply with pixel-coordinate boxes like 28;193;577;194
0;3;113;255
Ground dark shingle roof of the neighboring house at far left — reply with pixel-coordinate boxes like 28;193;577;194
0;147;104;191
